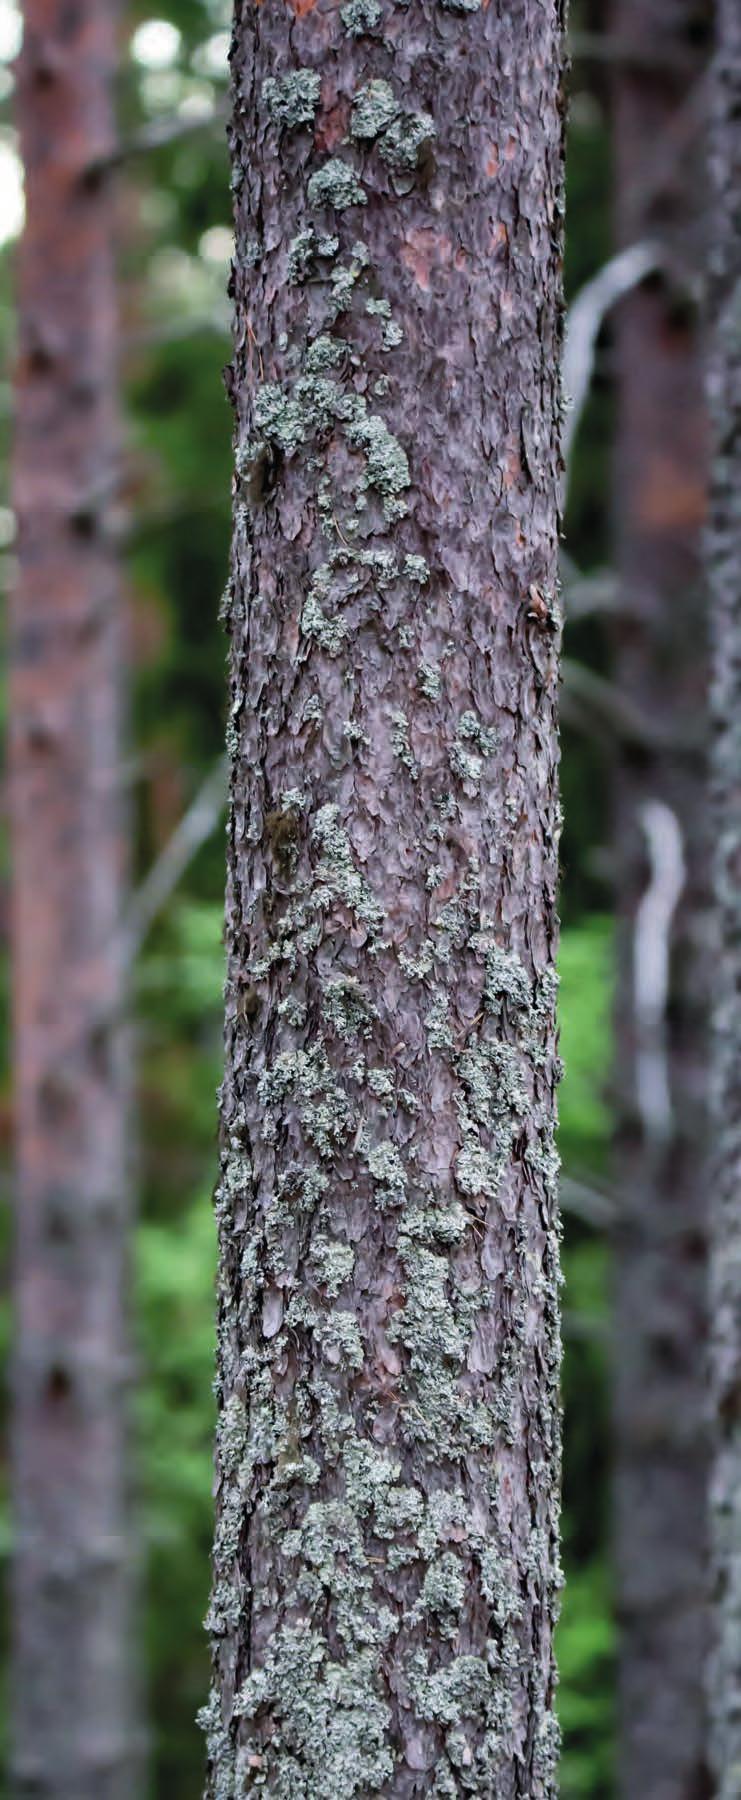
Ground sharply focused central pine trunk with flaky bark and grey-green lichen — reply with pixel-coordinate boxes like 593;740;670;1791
205;0;561;1800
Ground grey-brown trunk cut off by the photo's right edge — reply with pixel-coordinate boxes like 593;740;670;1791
709;0;741;1800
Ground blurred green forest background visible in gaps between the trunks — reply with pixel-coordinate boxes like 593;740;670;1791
0;0;705;1800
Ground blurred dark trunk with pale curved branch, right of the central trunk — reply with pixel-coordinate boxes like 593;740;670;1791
613;0;709;1800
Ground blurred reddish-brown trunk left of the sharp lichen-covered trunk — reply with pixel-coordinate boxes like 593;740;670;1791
11;0;137;1800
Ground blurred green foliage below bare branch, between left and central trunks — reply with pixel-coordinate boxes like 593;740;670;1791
135;900;223;1800
